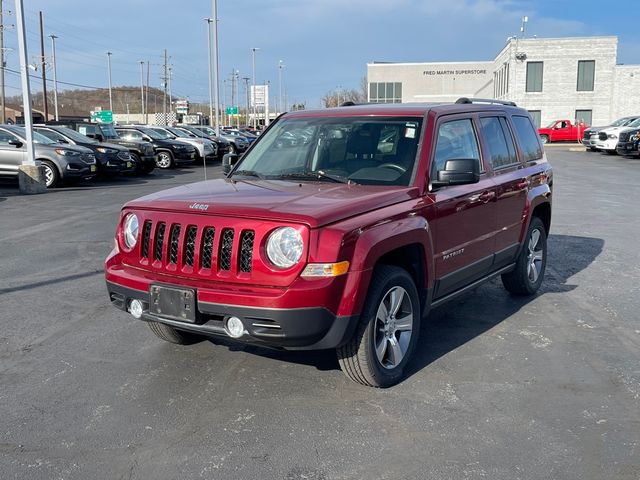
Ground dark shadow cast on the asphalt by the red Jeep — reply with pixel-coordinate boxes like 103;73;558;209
210;235;604;380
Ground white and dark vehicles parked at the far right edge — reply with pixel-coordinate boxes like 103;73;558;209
582;115;640;156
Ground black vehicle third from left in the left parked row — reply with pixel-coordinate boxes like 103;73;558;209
53;121;156;173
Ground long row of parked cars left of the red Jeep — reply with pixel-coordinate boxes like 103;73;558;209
0;122;257;188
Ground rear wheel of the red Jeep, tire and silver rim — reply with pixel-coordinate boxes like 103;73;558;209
502;217;547;295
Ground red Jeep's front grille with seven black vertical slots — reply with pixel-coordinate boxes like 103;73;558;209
140;220;256;275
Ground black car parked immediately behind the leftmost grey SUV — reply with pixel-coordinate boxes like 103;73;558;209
33;125;136;174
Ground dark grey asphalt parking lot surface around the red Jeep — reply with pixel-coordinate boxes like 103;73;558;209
0;151;640;480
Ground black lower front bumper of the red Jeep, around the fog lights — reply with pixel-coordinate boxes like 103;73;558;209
107;281;358;350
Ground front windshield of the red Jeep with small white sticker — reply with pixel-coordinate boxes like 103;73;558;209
233;117;422;185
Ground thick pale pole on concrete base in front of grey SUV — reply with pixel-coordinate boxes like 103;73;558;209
16;0;46;193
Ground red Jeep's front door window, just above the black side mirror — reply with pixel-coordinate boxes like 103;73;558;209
434;118;482;171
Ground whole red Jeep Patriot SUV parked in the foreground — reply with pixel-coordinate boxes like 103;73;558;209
106;98;553;387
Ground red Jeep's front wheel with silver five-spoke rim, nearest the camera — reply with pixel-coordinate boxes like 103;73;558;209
336;265;420;387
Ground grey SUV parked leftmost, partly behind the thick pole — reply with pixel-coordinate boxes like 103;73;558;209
0;125;98;188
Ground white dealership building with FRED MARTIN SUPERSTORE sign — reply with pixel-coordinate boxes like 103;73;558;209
367;36;640;125
